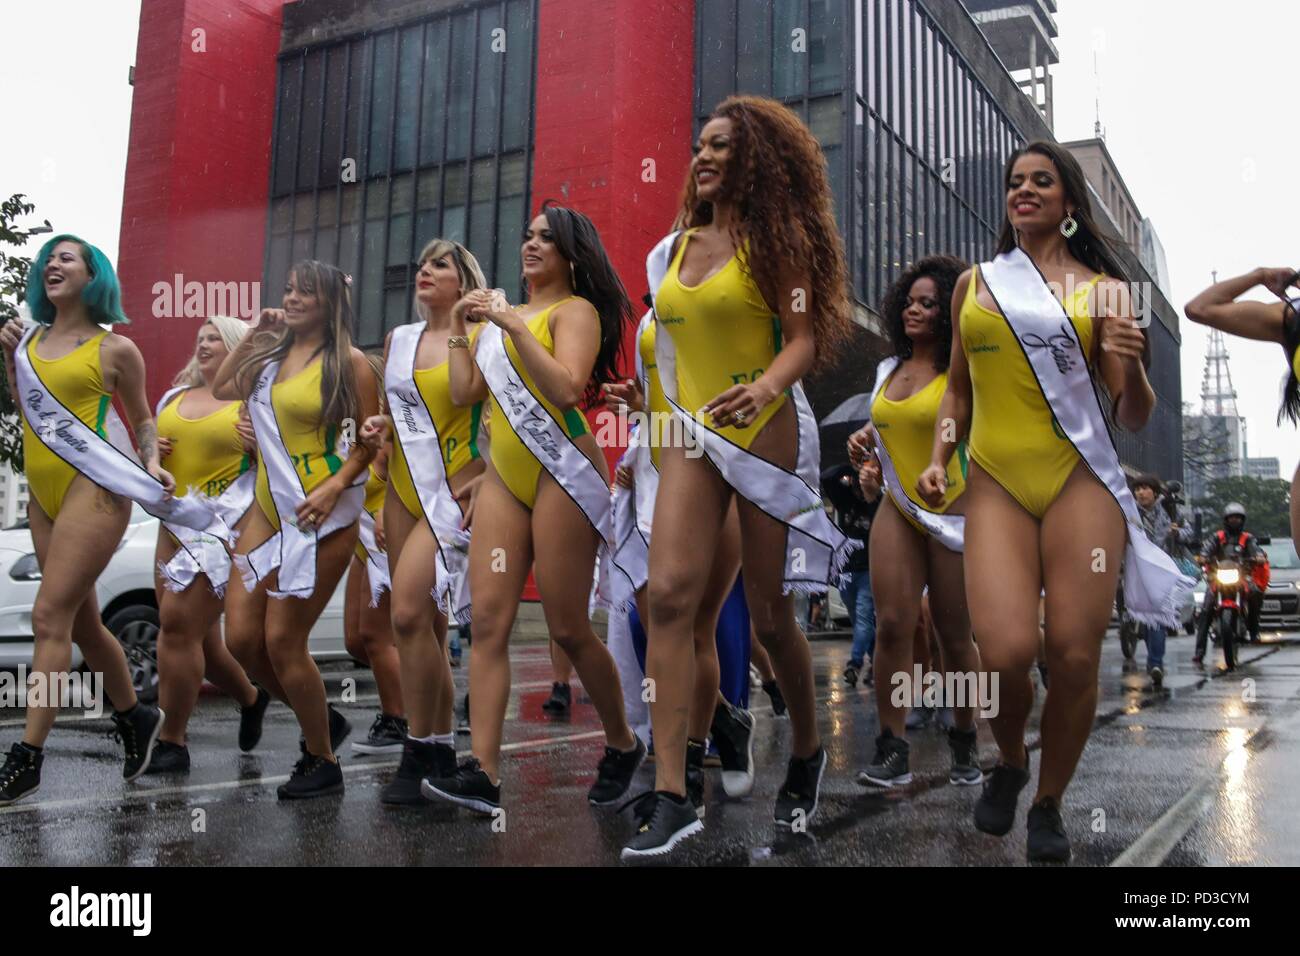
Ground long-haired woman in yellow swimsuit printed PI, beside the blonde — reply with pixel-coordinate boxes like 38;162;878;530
212;260;380;800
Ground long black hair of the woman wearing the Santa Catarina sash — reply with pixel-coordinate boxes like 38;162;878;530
542;199;636;406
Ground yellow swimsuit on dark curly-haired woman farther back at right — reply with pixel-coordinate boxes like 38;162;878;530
871;372;966;535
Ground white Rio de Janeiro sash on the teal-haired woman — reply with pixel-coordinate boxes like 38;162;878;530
13;325;230;541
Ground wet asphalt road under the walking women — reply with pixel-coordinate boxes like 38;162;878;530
0;633;1300;866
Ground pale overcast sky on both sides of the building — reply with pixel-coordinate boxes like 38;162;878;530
0;0;1300;477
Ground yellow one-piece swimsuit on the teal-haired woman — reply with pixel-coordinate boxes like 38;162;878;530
22;332;113;520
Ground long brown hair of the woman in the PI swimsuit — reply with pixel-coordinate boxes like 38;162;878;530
235;259;360;428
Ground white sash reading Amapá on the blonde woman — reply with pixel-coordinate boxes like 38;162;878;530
384;323;471;624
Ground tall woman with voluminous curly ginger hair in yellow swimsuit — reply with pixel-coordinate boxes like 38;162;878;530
623;96;852;858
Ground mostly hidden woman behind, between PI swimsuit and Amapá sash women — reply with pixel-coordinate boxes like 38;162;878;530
343;354;407;754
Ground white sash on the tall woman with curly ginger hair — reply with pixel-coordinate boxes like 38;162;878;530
646;233;862;594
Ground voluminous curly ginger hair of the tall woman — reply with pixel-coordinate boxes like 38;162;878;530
675;96;852;368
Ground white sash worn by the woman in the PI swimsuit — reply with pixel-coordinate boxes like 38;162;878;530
234;362;367;598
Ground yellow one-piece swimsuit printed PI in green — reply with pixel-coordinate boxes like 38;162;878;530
257;359;343;531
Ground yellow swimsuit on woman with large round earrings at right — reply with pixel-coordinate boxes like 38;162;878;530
961;268;1101;518
